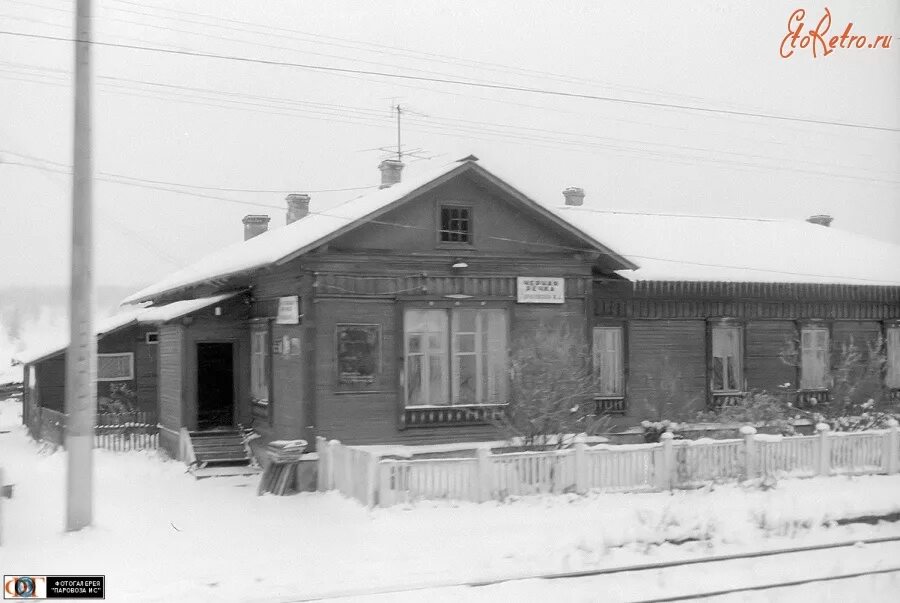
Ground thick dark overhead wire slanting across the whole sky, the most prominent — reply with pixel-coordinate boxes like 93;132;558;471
0;30;900;132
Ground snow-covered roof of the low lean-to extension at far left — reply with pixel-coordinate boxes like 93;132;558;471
14;291;239;364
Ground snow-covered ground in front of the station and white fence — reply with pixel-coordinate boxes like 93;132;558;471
0;401;900;601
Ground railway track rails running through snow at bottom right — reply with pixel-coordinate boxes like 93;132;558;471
284;536;900;603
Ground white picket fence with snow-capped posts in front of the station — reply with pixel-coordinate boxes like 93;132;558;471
317;422;900;506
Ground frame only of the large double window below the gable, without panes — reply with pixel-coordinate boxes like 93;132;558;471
398;302;512;410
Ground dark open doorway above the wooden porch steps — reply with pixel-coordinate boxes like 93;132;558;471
197;343;234;430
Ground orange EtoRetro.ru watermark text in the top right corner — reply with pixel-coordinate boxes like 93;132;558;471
779;7;893;59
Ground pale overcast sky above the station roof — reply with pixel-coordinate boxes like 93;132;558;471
0;0;900;286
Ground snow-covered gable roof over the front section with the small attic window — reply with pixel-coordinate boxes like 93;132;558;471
122;156;629;304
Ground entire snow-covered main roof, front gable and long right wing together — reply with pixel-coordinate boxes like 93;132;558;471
123;157;900;304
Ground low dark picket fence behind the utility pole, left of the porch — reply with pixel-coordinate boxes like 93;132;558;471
32;408;159;450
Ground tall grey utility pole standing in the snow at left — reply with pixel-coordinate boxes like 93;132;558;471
66;0;97;532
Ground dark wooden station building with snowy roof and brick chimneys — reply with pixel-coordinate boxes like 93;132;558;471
109;156;900;452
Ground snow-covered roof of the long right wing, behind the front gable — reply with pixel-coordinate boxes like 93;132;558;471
556;206;900;285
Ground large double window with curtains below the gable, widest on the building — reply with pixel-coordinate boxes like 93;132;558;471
403;308;508;407
